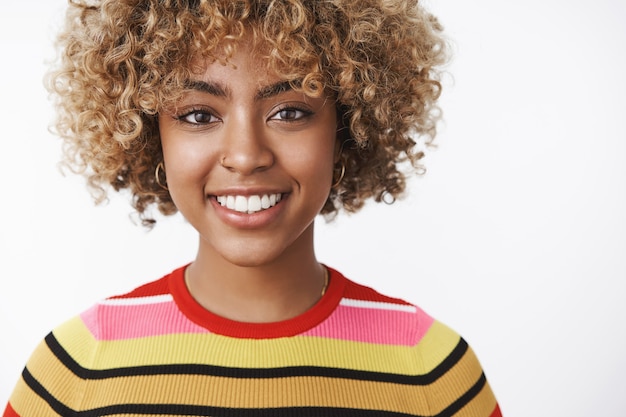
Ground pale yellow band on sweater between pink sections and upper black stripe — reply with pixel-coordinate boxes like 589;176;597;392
54;319;459;375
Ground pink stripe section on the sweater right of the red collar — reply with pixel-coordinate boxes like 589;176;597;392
305;305;434;346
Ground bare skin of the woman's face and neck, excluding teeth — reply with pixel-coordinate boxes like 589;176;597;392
159;43;338;322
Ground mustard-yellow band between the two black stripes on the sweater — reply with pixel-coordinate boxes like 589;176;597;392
24;342;486;416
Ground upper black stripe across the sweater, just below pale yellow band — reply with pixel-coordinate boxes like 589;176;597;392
45;333;468;385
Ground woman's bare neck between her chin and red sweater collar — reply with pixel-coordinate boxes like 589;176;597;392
186;231;327;323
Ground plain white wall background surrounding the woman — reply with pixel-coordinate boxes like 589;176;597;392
0;0;626;417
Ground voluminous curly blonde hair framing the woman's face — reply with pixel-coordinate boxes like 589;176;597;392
48;0;447;225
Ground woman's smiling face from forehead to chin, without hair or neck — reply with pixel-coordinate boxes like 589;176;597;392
159;44;337;266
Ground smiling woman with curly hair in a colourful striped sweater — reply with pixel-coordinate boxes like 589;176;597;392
4;0;501;417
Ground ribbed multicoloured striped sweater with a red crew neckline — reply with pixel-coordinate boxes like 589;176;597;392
4;268;501;417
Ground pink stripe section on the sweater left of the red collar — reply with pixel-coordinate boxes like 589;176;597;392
81;301;208;340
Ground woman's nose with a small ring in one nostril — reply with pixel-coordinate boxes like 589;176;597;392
220;115;274;175
